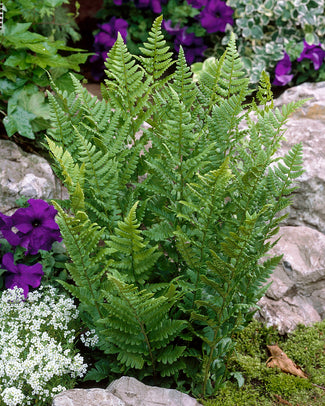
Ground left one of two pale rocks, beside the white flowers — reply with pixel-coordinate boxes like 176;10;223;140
52;388;126;406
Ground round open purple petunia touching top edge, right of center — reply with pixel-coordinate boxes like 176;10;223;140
197;0;234;34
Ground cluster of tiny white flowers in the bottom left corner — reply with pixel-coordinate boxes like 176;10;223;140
0;287;87;406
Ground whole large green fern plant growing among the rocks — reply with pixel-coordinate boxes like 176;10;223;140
47;17;303;396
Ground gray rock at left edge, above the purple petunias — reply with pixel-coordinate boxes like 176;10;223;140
0;139;67;214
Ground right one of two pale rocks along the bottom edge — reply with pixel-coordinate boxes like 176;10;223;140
107;376;200;406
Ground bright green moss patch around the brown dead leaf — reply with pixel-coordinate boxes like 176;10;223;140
201;321;325;406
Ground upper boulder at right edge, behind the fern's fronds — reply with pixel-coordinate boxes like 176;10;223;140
275;82;325;233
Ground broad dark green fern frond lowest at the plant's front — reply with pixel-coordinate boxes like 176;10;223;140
101;277;185;374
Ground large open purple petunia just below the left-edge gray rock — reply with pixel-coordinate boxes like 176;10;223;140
7;199;62;255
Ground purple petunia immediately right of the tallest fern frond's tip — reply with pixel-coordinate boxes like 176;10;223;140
162;20;207;65
